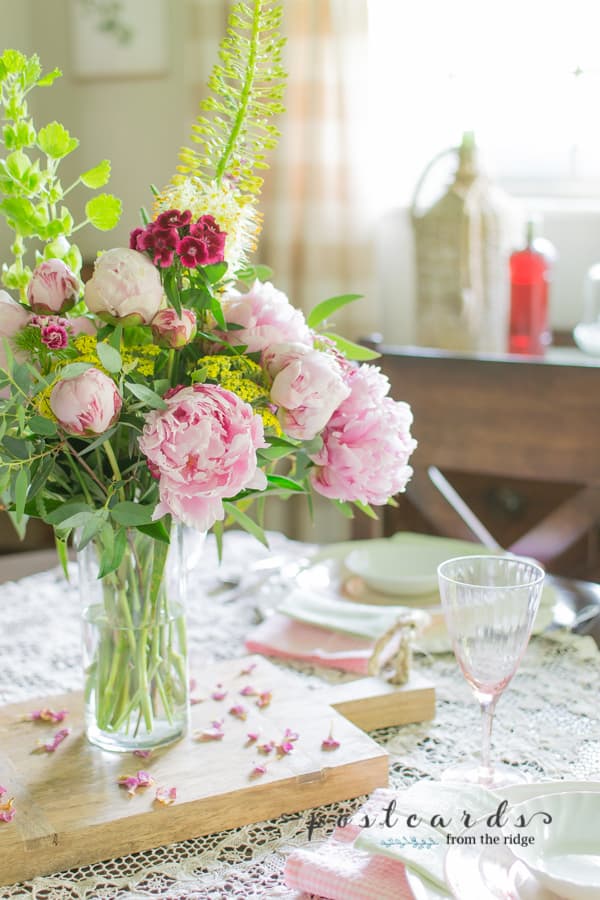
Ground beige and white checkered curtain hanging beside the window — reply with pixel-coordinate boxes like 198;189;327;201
184;0;379;339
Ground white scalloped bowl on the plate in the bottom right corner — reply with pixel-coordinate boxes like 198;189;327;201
513;791;600;900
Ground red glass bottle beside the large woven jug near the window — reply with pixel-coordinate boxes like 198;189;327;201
508;222;551;356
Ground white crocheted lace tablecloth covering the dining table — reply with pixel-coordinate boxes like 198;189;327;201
0;533;600;900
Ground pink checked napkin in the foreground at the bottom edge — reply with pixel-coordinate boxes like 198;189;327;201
284;790;414;900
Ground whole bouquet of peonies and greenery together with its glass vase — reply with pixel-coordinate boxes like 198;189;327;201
0;0;415;749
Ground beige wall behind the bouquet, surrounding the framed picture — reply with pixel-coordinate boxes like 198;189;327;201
0;0;189;268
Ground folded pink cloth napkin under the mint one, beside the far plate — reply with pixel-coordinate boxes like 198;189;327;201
246;613;374;675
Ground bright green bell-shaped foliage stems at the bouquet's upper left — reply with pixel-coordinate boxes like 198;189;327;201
0;50;121;298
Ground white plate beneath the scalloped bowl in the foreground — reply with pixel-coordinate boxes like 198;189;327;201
442;781;600;900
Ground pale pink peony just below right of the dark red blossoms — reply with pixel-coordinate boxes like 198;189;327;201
221;280;312;353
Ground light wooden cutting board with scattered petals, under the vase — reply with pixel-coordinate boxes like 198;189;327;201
0;656;434;885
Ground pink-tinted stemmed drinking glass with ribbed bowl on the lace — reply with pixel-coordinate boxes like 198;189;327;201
438;556;544;788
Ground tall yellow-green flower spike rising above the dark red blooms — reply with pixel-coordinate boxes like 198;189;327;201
179;0;285;197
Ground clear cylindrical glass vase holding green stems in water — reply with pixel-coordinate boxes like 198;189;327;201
78;525;189;752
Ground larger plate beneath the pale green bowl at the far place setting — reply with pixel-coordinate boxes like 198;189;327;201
284;532;556;653
